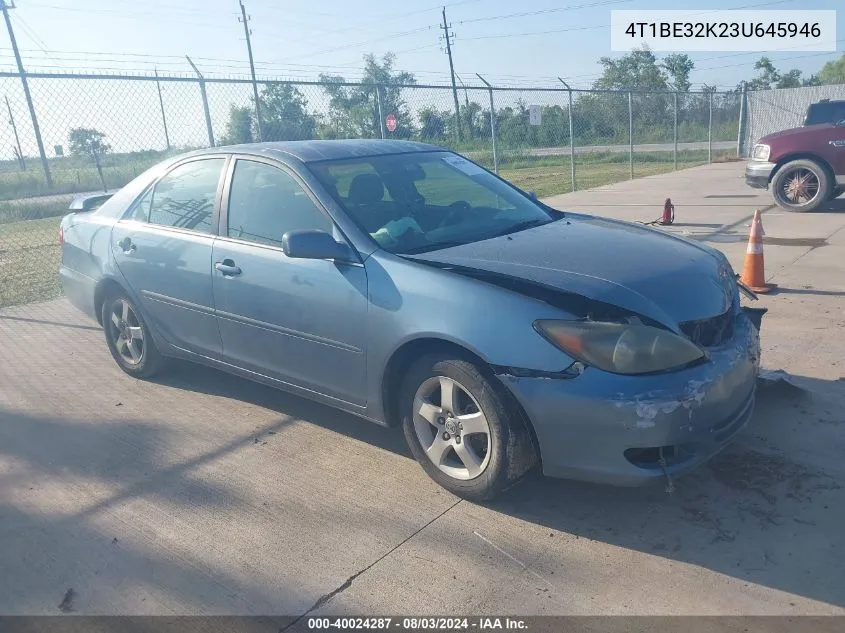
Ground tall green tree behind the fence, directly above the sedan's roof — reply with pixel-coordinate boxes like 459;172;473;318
320;53;416;138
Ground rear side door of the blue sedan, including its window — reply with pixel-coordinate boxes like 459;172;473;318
112;156;228;359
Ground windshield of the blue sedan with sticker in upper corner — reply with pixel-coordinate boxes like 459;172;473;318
309;152;553;254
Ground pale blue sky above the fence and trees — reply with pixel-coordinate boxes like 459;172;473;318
0;0;845;159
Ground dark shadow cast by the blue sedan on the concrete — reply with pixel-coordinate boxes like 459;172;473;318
147;367;845;606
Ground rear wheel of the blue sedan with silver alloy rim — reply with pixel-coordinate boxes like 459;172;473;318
102;292;165;378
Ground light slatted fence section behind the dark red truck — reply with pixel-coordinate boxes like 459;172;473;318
741;84;845;156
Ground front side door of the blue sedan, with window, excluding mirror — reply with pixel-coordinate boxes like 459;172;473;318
212;159;368;405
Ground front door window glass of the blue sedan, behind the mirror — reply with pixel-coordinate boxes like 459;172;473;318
228;160;332;246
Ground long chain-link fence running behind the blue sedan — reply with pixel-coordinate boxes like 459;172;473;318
0;73;740;307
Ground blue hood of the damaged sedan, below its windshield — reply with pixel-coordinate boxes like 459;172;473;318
409;214;736;331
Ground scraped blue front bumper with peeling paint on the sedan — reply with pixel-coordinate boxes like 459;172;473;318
498;311;760;486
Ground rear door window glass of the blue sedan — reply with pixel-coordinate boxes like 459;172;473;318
147;158;226;233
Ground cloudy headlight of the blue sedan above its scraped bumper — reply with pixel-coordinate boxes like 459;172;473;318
534;321;704;374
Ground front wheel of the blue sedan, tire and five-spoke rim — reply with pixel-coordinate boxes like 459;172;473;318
400;355;537;501
